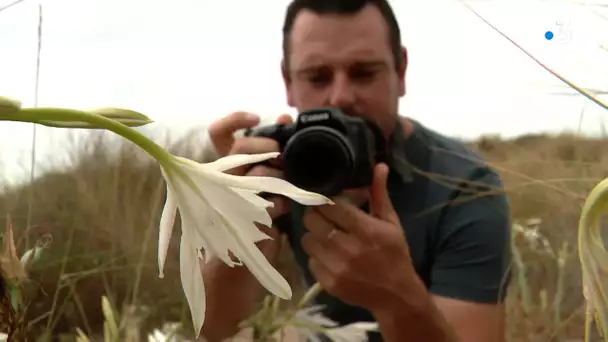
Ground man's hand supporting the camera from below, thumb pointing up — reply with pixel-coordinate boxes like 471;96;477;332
302;164;424;313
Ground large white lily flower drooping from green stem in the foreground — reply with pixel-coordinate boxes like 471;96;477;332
158;153;332;336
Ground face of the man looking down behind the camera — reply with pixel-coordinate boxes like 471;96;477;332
283;5;407;135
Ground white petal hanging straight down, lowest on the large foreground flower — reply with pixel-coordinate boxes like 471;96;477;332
179;234;207;338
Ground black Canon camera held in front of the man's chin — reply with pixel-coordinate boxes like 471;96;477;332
245;107;386;197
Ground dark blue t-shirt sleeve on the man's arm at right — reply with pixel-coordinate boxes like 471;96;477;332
430;169;511;303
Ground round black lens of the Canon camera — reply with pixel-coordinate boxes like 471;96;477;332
283;126;354;196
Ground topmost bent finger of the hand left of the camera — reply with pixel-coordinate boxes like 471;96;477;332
208;112;260;155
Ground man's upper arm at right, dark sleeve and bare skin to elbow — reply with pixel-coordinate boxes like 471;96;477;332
430;170;511;342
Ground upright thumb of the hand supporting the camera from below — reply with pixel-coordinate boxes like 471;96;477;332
369;163;399;224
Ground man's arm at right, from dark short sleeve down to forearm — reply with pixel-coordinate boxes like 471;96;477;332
373;172;510;342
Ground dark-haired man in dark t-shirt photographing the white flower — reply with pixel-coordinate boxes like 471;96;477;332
202;0;510;342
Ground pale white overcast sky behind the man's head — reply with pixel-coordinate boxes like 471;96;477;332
0;0;608;184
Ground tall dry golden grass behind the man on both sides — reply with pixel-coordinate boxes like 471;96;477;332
0;129;608;342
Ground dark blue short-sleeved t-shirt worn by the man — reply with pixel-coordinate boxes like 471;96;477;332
276;119;511;342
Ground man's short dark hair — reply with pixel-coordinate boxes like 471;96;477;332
283;0;404;72
